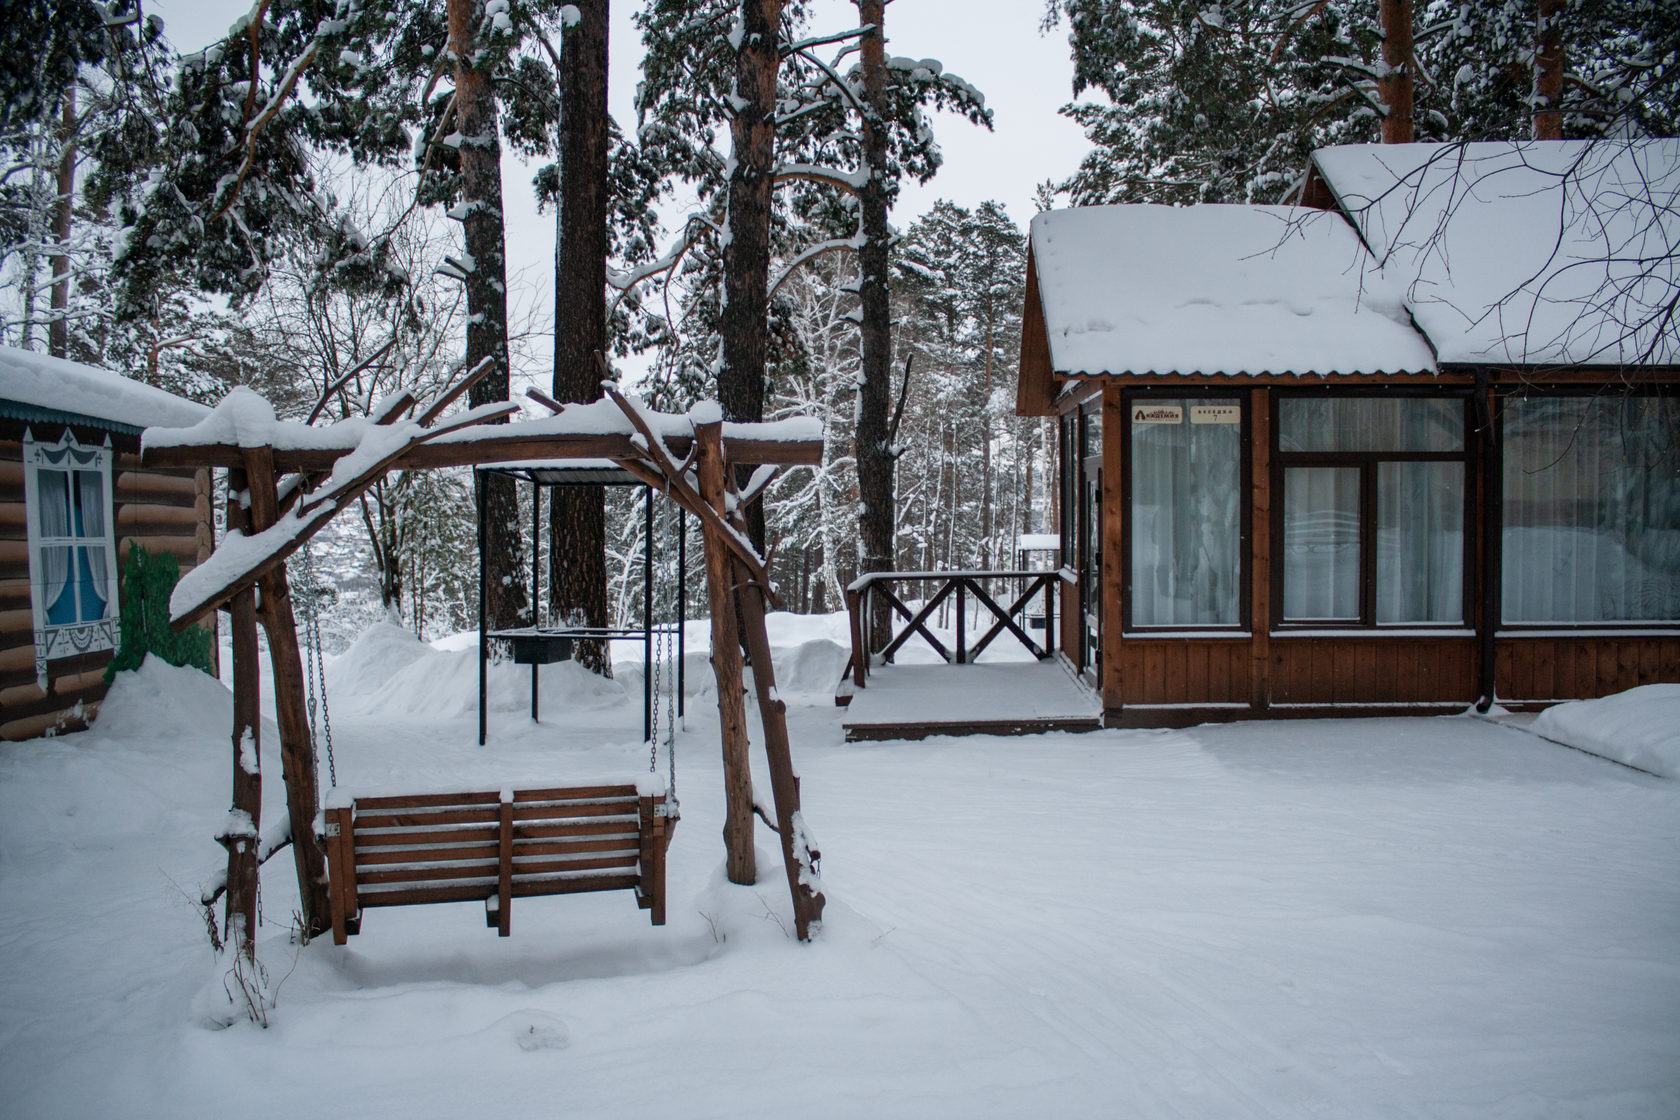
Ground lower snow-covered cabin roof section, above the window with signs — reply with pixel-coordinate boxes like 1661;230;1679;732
1032;205;1435;376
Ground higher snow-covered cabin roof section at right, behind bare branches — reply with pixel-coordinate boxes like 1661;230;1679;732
1314;139;1680;366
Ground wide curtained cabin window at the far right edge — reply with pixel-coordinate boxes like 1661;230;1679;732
1502;395;1680;625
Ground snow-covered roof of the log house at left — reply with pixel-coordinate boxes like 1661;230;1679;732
0;346;210;435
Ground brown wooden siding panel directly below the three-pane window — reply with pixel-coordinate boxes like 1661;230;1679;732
1267;635;1477;705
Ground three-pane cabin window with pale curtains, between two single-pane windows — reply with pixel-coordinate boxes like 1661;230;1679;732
1273;396;1467;626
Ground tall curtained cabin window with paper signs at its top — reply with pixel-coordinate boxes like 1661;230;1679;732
1127;398;1247;626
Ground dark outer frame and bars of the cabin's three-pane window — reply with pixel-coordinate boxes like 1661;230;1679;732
1268;386;1478;633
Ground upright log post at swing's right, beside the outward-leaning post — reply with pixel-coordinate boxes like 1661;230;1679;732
696;421;758;885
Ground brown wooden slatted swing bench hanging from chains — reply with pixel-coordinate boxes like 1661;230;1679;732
324;784;675;945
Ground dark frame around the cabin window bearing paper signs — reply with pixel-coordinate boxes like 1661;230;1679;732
1119;385;1253;638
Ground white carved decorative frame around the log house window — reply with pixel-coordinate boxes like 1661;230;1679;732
24;428;123;692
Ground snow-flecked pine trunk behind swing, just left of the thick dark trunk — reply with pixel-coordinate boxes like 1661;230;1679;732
449;0;529;628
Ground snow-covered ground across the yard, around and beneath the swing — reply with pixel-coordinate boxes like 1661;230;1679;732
0;618;1680;1118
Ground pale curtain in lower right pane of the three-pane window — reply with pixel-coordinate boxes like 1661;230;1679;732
1376;462;1465;623
